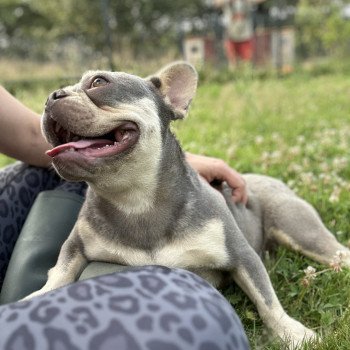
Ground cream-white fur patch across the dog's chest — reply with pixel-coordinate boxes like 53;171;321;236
80;219;229;268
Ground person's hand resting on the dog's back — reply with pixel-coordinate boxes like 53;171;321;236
186;153;248;204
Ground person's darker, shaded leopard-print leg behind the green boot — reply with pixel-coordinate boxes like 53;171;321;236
0;162;85;287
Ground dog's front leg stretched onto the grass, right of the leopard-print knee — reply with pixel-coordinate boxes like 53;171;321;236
233;247;315;348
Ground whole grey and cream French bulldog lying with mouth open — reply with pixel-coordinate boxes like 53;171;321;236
27;63;350;344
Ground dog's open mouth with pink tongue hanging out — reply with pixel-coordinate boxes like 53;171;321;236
46;121;140;157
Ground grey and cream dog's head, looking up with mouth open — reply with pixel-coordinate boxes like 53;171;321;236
42;62;197;182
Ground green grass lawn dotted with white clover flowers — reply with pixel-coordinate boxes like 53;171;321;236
0;67;350;350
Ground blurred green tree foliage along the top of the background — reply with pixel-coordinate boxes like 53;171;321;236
0;0;350;63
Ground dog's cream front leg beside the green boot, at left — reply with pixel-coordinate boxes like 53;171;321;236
25;234;87;299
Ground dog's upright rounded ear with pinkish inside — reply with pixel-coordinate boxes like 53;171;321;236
148;62;198;119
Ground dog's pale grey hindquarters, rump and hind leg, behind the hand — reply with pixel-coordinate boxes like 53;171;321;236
244;174;350;267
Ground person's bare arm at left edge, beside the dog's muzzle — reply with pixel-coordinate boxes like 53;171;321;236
0;86;50;167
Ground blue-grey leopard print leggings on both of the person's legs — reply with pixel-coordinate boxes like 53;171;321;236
0;163;249;350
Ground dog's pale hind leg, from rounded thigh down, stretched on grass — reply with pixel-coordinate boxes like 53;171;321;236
265;195;350;267
